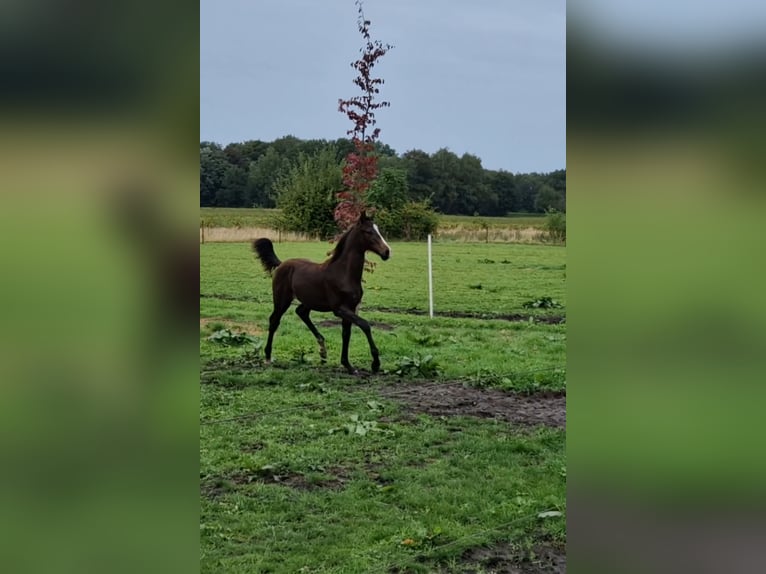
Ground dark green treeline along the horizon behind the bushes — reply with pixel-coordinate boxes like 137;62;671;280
200;136;566;216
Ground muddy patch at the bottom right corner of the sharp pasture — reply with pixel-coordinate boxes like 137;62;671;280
460;544;566;574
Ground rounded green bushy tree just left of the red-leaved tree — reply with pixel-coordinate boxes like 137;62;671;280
274;147;343;239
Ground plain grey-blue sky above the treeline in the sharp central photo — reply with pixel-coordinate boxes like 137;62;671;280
200;0;566;172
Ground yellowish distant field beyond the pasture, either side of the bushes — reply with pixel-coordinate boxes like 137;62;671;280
200;207;546;243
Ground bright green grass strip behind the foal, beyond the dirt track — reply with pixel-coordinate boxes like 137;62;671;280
200;242;566;315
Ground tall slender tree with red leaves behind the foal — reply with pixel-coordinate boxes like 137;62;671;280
334;0;393;231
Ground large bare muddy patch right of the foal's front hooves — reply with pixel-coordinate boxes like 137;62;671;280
381;383;566;428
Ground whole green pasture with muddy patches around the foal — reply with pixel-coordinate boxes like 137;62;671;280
200;242;566;573
